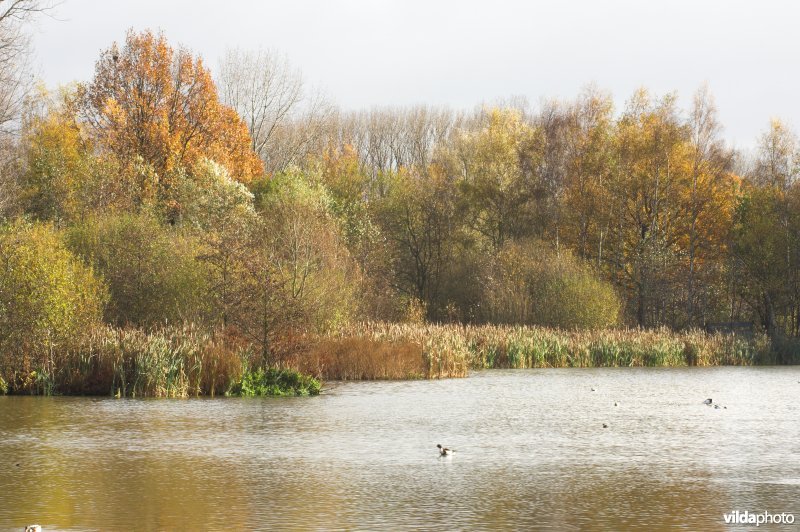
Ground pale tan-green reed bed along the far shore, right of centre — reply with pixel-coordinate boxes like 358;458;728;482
324;322;788;378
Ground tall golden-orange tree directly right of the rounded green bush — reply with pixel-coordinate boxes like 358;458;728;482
606;90;690;326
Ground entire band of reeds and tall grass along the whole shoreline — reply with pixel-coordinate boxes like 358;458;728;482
0;322;800;397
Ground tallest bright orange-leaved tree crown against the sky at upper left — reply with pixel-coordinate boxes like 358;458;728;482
81;31;262;209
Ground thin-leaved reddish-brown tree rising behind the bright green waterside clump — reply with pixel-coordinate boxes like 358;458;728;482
239;170;360;360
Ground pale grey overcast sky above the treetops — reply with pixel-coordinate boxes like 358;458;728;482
29;0;800;147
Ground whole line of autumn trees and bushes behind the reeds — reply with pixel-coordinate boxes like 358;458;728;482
0;23;800;370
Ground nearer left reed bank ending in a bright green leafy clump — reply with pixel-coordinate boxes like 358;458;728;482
0;325;320;397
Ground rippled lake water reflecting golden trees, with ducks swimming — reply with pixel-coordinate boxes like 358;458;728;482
0;367;800;531
